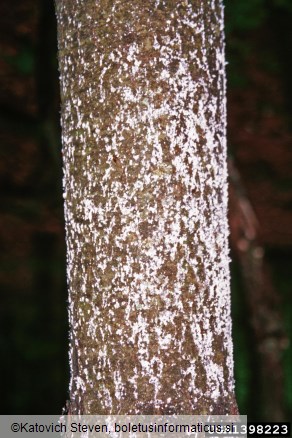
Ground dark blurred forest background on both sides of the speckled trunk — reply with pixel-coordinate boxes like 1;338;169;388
0;0;292;421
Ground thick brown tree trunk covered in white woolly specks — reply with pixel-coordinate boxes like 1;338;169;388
56;0;236;414
